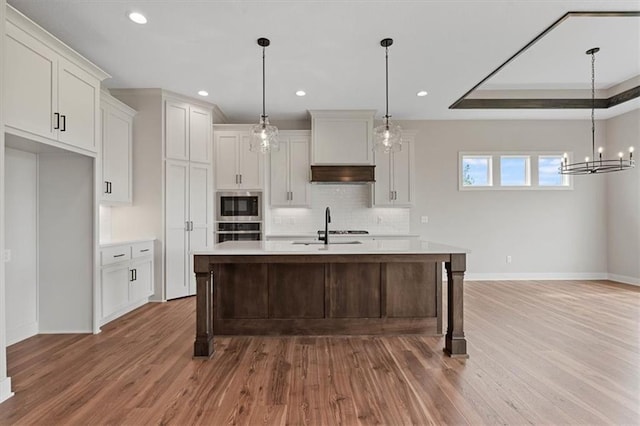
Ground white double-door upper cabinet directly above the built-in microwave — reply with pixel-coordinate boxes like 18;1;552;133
213;125;264;190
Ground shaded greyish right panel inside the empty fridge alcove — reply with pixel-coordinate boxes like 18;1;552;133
38;154;95;333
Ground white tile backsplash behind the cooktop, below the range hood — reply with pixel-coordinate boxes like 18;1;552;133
267;184;410;234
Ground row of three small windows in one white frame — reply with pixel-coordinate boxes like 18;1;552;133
458;151;573;191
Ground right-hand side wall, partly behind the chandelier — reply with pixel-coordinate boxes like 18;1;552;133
606;110;640;285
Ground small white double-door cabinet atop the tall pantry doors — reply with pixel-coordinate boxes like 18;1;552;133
165;100;211;164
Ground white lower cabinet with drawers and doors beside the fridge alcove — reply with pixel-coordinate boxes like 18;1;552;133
100;241;153;325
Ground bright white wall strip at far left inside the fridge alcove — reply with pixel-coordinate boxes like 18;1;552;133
4;148;38;345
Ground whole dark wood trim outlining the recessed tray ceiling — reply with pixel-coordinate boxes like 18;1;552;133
449;11;640;109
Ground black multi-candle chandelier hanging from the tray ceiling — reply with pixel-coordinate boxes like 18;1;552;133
560;47;635;175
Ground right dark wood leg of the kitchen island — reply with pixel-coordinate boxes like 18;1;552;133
444;253;469;358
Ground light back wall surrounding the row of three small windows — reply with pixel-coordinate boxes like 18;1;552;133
399;120;607;279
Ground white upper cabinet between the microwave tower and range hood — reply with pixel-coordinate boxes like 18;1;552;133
270;131;311;207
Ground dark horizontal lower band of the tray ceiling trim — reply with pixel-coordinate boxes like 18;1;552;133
456;86;640;109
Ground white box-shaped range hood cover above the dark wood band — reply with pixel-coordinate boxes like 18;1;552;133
309;110;375;165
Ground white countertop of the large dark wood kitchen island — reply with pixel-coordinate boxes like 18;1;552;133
192;237;470;256
